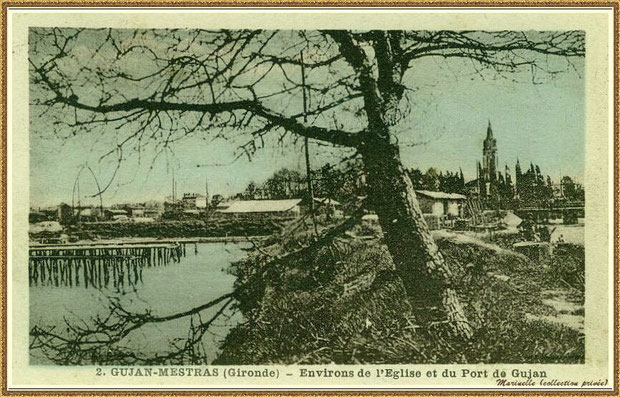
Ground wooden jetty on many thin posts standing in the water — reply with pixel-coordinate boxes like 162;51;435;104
28;242;191;289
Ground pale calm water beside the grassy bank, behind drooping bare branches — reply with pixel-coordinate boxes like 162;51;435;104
30;243;244;364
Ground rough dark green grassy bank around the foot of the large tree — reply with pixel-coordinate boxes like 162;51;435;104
216;220;585;364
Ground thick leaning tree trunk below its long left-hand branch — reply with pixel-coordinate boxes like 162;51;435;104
361;139;472;340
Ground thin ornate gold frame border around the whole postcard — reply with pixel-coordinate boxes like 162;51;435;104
0;0;620;397
